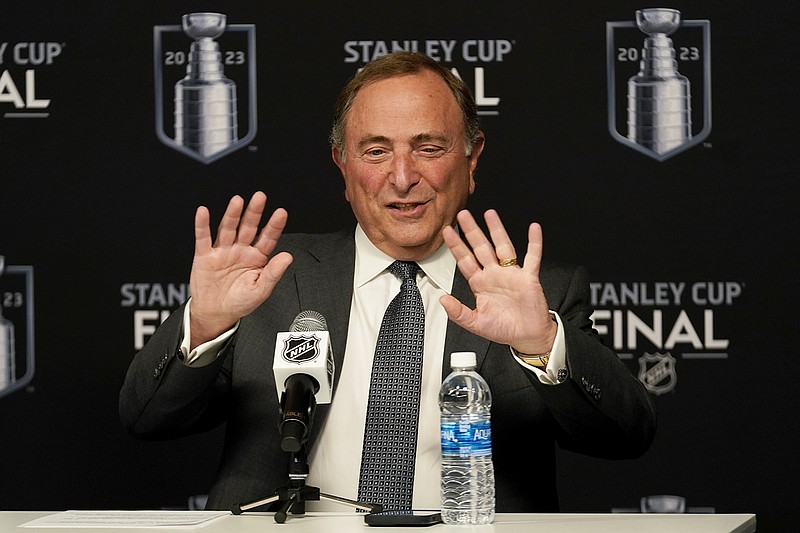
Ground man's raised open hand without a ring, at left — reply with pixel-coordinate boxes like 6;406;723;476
189;191;292;349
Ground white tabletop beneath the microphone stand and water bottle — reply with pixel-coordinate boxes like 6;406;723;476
0;511;756;533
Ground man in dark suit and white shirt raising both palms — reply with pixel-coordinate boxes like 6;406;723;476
120;53;655;512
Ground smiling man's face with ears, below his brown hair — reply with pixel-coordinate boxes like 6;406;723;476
332;70;483;261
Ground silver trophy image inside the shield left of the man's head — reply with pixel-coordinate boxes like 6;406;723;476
175;13;238;157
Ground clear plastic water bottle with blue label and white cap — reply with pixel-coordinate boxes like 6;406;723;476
439;352;494;524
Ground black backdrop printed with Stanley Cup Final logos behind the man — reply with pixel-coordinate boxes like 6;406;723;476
0;0;800;530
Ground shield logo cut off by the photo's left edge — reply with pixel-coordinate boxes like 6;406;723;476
0;256;34;397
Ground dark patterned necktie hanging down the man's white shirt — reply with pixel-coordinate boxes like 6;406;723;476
358;261;425;510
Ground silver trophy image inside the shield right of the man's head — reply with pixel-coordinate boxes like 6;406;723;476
628;8;692;154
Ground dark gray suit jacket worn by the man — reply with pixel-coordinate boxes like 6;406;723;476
120;230;655;512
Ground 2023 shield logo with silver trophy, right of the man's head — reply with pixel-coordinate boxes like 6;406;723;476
606;8;711;161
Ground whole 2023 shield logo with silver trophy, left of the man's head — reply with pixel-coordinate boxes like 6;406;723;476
153;13;256;164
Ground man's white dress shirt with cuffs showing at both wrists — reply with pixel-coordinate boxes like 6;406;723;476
181;226;566;511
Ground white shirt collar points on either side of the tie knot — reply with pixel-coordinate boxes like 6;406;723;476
355;224;456;293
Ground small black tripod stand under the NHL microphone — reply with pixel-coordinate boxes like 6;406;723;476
231;445;383;524
